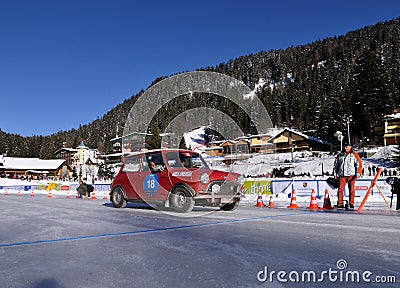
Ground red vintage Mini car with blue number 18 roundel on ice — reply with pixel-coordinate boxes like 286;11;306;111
110;149;244;213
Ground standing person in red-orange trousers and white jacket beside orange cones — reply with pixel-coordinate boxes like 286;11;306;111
334;143;362;209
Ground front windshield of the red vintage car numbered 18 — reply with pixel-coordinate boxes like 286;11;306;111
166;151;209;169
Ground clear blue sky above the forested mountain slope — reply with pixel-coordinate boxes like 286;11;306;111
0;0;400;137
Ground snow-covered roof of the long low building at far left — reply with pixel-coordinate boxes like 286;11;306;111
0;157;65;170
